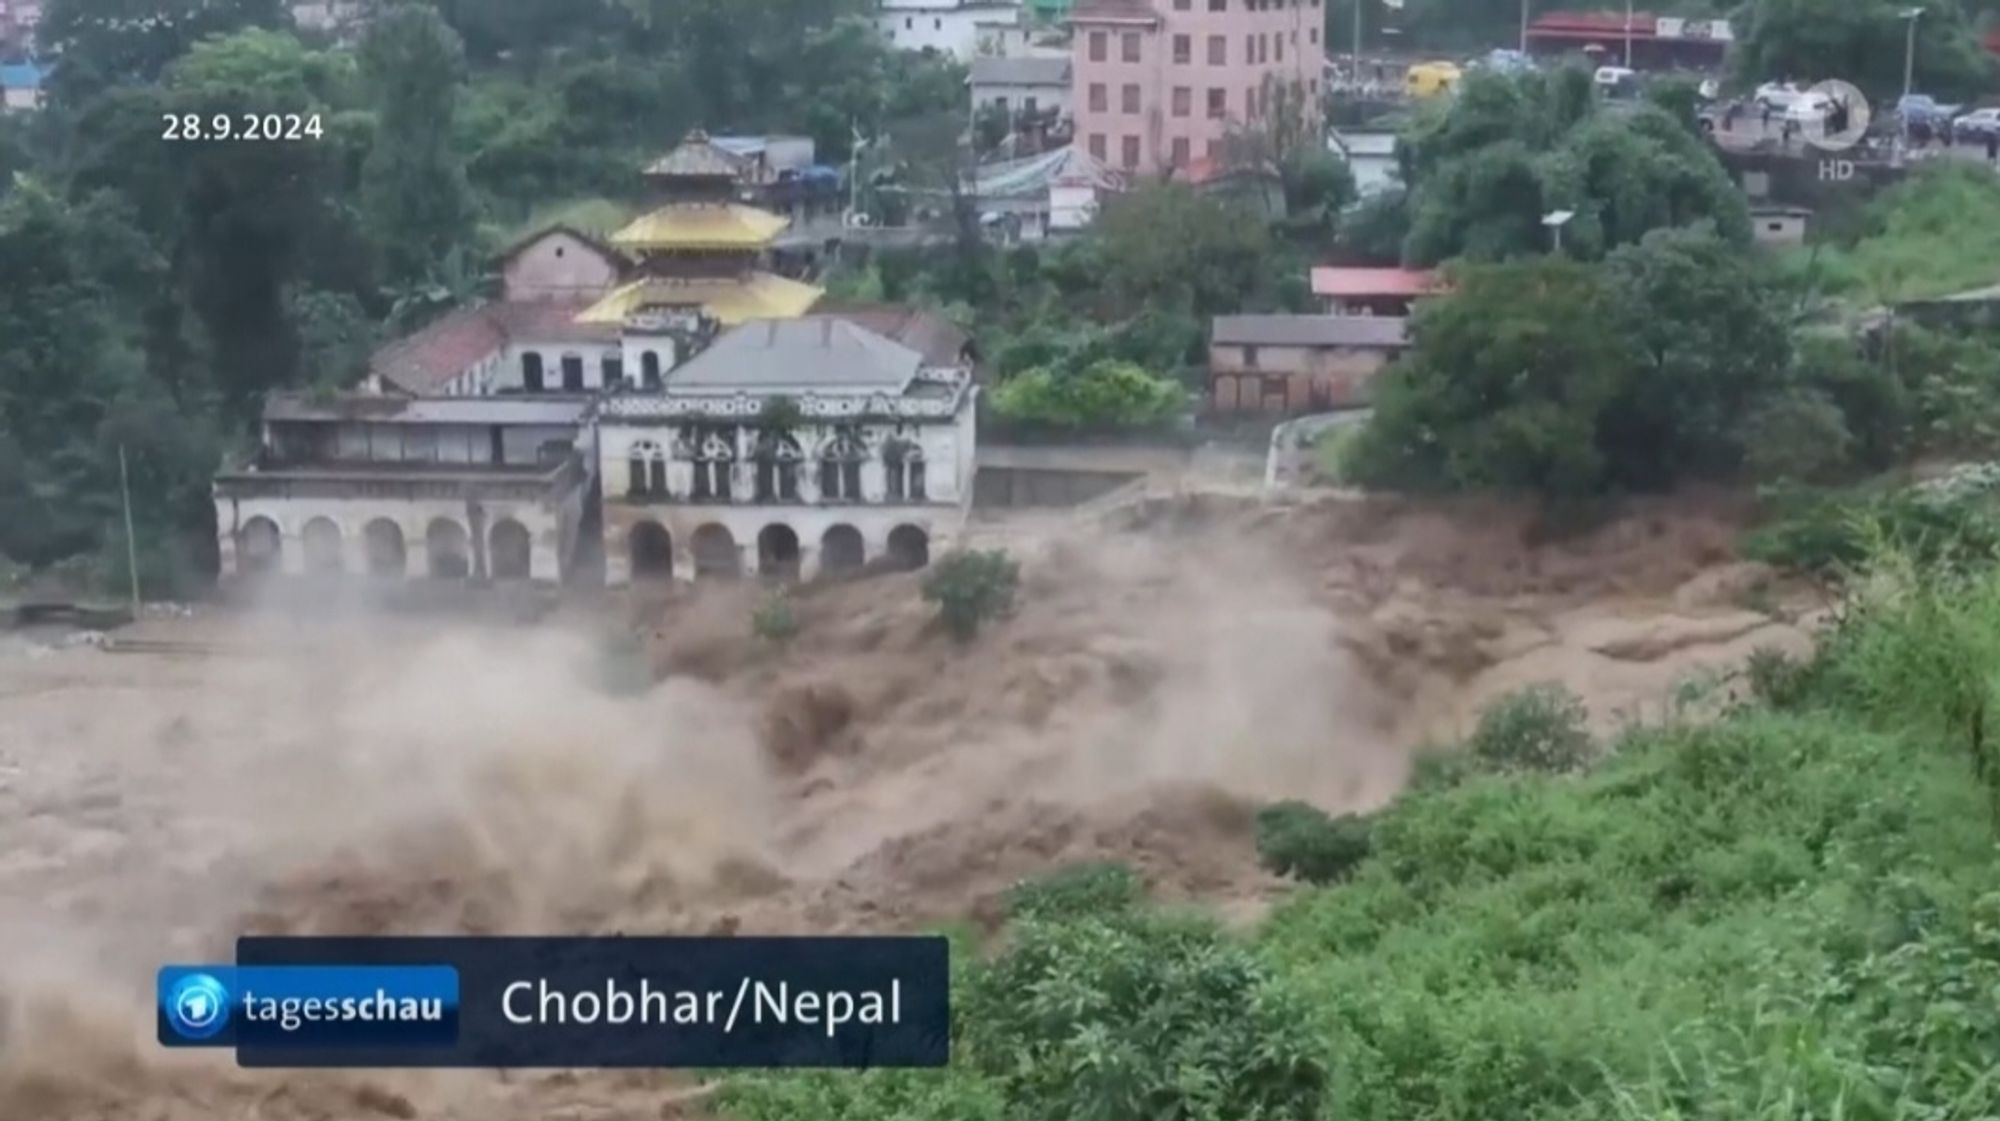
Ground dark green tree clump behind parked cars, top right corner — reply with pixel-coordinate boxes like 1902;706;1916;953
1734;0;1992;102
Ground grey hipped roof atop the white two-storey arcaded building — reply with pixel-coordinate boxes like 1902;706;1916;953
666;316;924;394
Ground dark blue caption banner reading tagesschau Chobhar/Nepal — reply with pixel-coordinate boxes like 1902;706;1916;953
158;937;950;1067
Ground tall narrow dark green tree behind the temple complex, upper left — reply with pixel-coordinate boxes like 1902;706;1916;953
360;4;472;284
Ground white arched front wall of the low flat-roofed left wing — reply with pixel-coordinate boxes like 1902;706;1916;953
216;488;582;583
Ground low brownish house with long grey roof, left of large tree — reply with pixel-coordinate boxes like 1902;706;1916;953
1208;314;1410;414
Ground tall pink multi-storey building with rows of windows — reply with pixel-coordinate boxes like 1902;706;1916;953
1070;0;1326;172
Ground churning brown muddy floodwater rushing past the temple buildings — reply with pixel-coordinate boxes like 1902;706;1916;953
0;492;1806;1121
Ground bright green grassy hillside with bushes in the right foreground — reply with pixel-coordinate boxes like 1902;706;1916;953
724;510;2000;1121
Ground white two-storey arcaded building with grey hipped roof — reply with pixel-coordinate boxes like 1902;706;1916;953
596;316;978;585
